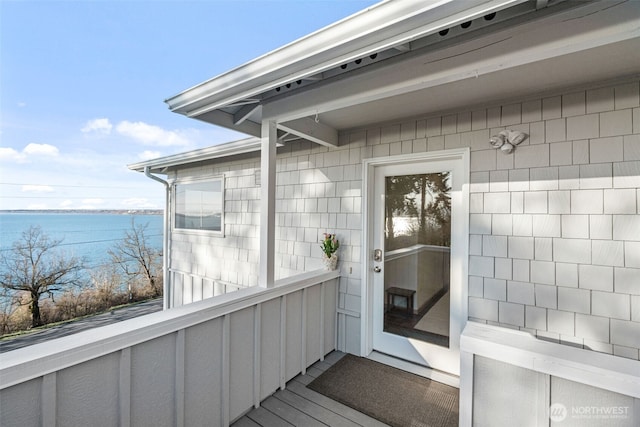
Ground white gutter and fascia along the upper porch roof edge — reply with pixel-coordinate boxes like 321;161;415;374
165;0;526;117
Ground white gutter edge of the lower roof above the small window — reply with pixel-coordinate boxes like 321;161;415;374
127;138;261;173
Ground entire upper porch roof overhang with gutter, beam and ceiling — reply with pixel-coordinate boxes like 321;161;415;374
166;0;640;146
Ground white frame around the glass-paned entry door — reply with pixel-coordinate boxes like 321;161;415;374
360;148;470;376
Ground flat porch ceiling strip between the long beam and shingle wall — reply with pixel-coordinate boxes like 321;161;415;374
320;41;640;130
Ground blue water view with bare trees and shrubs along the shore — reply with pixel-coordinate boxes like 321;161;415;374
0;211;163;335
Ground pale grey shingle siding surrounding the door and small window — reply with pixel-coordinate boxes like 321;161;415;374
171;79;640;360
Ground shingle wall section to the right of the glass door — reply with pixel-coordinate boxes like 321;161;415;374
458;82;640;359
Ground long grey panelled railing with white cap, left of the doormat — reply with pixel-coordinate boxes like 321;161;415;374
0;272;339;427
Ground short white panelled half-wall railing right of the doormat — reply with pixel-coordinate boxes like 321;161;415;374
460;322;640;427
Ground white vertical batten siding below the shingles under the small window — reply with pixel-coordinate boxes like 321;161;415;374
169;269;248;308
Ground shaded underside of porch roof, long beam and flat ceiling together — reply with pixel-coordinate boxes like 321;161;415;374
262;1;640;130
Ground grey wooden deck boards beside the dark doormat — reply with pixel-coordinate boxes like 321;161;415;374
232;351;387;427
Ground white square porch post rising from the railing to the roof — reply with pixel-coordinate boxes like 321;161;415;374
258;120;278;288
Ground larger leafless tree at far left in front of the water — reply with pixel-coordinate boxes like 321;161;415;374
0;226;82;327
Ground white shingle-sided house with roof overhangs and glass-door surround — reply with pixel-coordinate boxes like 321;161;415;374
1;0;640;426
